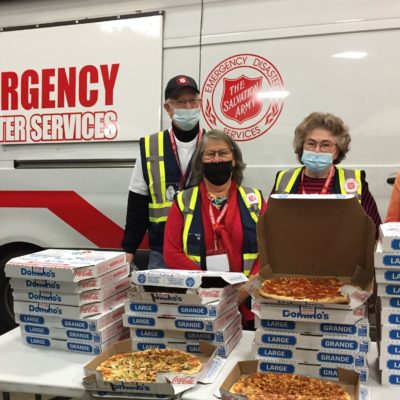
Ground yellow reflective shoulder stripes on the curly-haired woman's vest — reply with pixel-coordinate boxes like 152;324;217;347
275;167;362;202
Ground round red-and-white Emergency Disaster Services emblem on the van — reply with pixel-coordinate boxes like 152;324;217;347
201;54;287;141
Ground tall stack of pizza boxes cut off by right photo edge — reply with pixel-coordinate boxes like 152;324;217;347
375;222;400;386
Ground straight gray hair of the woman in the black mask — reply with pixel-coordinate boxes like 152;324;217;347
192;129;246;185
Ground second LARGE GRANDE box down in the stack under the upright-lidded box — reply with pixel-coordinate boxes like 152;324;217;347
254;329;370;353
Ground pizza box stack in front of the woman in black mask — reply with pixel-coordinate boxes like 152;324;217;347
124;269;247;356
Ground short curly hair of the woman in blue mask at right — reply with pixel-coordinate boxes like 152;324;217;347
293;112;351;164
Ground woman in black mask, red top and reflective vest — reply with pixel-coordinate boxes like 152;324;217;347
164;130;266;328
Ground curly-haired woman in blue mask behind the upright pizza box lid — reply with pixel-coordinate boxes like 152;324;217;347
273;112;381;237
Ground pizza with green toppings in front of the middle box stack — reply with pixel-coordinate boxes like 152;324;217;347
96;349;202;382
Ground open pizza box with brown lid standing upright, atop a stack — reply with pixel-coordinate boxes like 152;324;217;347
249;195;375;309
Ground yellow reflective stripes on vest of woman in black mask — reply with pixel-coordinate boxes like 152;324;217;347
177;186;262;276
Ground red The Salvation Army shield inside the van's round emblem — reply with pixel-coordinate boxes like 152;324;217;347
221;75;262;124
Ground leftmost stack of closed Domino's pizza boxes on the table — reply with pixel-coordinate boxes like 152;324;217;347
5;249;131;354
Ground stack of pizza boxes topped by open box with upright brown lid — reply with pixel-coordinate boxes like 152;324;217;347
251;195;375;382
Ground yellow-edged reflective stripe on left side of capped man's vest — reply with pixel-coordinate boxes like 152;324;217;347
144;131;172;222
